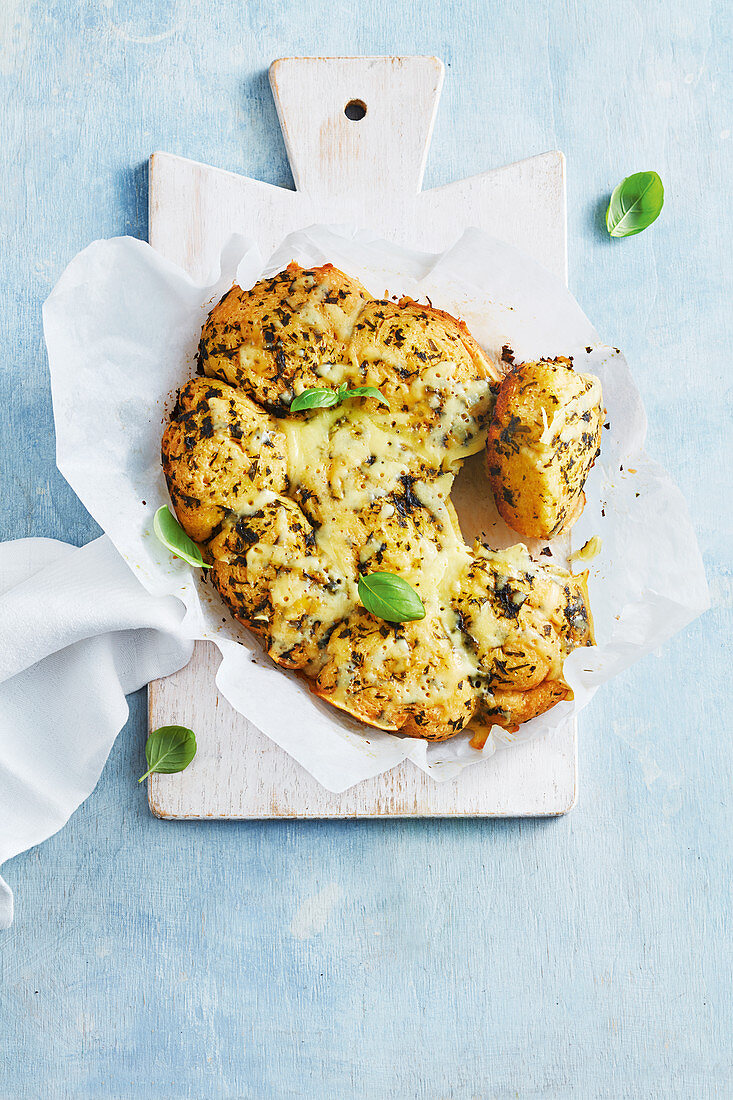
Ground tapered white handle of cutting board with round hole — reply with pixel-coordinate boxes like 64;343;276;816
270;57;444;199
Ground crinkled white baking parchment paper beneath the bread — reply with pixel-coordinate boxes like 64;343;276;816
44;226;709;792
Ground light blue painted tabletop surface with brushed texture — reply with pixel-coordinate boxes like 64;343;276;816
0;0;733;1100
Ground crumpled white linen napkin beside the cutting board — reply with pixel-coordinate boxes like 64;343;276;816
0;536;193;928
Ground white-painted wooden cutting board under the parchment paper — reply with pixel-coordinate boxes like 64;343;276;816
149;57;577;818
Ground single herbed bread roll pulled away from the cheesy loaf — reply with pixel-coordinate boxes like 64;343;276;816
486;359;603;539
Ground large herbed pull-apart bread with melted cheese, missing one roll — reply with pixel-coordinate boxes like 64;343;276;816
163;264;592;747
